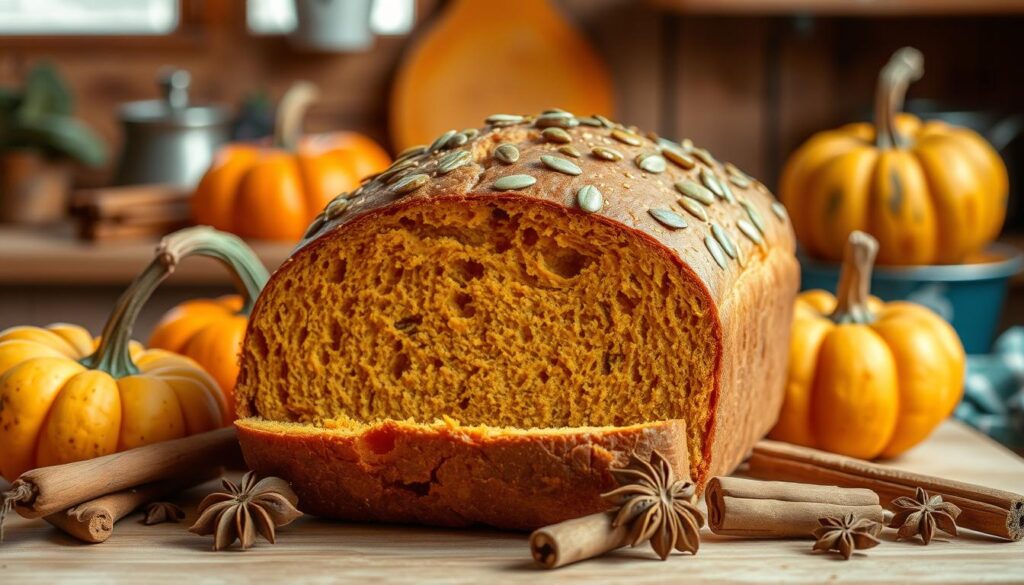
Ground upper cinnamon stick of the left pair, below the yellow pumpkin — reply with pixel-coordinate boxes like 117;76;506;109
0;427;240;540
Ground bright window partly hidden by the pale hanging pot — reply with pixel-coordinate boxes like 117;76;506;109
248;0;416;35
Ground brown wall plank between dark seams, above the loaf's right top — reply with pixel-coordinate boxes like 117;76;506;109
666;16;771;176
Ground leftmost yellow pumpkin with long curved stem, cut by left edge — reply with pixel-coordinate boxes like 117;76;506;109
0;227;260;479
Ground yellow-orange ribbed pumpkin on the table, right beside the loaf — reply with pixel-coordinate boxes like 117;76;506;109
771;232;965;459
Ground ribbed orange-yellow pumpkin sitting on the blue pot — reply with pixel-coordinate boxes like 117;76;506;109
779;48;1008;264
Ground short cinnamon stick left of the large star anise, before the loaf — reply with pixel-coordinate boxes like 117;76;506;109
529;510;630;569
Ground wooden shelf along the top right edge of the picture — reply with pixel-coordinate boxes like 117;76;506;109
647;0;1024;16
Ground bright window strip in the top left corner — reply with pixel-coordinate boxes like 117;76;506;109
0;0;179;36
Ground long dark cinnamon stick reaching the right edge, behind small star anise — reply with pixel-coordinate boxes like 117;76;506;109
749;441;1024;540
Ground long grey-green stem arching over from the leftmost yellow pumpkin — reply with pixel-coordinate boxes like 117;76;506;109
81;225;269;378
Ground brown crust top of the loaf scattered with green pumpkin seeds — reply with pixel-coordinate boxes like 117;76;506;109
299;110;796;298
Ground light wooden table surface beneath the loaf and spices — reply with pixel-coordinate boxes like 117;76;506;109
0;422;1024;585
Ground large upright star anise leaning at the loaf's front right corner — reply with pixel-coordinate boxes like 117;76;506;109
602;451;705;560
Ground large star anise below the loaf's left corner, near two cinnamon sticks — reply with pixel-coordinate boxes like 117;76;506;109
188;471;302;550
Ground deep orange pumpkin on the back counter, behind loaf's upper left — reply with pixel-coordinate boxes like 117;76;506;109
191;83;391;241
